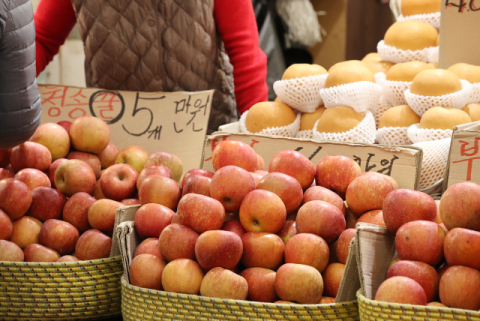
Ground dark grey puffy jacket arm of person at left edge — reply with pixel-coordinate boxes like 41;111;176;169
0;0;42;149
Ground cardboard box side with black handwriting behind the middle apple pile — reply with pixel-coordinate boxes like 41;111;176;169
201;123;423;190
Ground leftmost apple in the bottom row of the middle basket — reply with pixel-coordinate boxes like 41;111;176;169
128;254;166;291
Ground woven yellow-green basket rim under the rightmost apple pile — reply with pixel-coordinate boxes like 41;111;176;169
357;291;480;321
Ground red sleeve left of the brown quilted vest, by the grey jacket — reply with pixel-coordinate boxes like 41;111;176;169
34;0;77;76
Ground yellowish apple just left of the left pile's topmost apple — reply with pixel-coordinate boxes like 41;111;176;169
30;123;70;160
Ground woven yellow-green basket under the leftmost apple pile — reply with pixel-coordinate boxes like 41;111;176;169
0;256;123;320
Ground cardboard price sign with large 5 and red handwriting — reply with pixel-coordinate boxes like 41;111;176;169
39;85;213;173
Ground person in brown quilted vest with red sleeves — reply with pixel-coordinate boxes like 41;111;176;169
35;0;268;134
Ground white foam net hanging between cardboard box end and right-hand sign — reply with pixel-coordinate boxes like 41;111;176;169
413;138;451;190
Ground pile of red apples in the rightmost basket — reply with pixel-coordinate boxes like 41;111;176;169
375;182;480;310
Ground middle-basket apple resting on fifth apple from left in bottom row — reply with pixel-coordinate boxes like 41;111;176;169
285;233;330;273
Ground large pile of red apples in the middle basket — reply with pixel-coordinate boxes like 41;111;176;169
129;140;397;304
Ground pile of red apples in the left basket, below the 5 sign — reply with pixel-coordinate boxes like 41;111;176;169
0;117;183;262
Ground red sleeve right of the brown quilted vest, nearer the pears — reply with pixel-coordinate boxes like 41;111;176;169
214;0;268;113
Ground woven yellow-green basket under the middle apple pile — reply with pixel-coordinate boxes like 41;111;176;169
122;276;360;321
